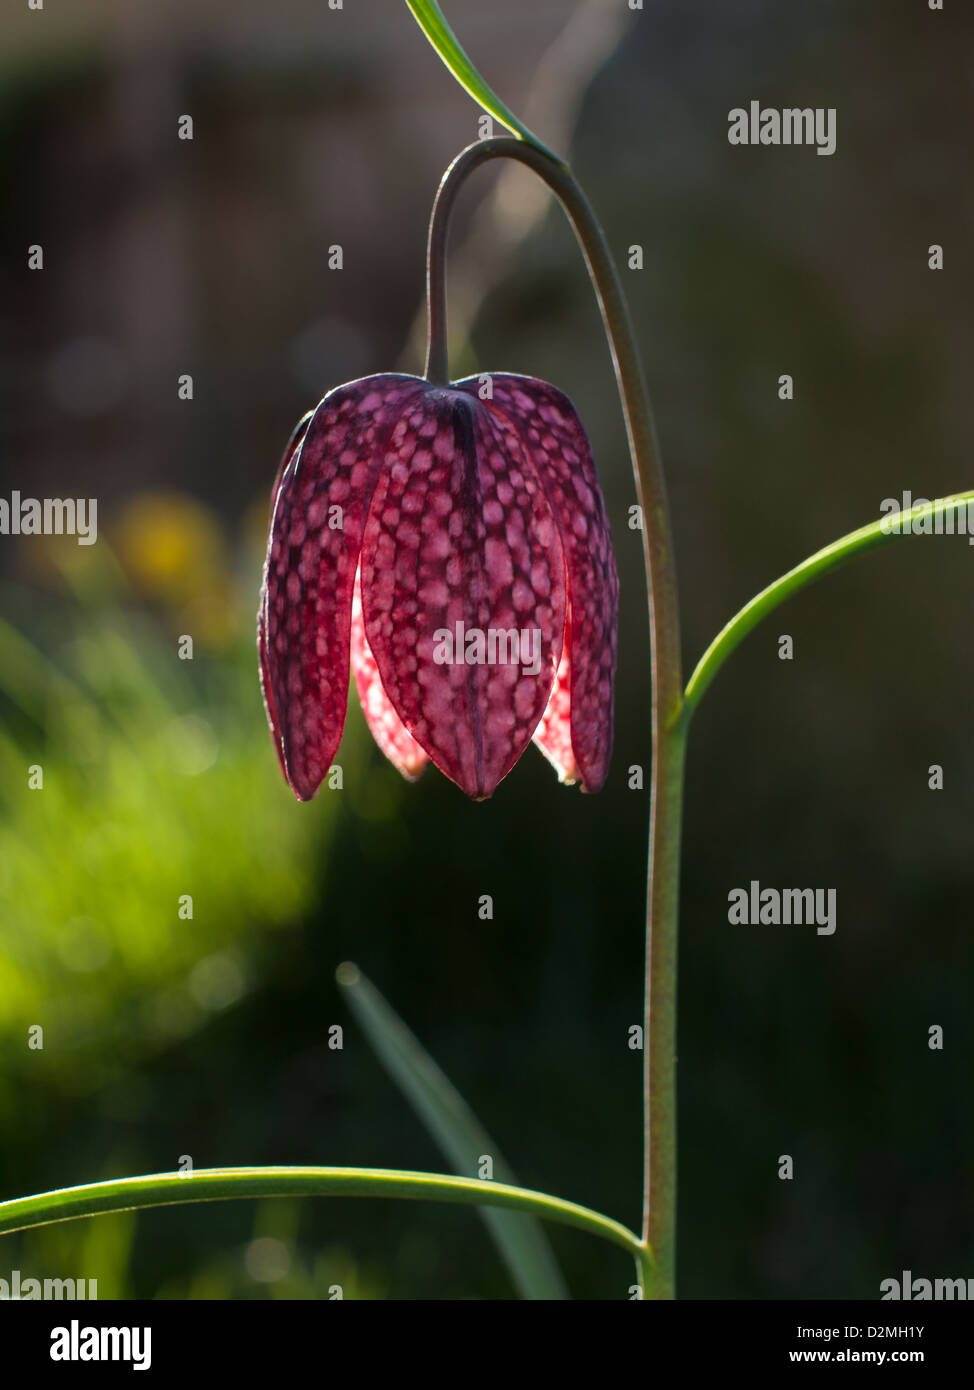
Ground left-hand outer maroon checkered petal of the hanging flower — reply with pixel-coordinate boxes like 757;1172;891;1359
261;375;424;801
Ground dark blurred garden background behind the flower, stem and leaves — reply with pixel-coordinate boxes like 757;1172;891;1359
0;0;974;1298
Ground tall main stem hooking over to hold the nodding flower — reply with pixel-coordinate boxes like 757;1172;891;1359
427;138;685;1298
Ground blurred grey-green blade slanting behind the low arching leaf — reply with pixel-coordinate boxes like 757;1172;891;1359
336;962;568;1298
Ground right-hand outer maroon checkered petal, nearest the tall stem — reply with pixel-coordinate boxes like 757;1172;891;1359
457;374;618;791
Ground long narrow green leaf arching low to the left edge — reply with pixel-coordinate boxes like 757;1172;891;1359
0;1168;642;1261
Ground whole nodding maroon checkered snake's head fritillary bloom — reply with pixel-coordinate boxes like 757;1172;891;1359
258;374;618;801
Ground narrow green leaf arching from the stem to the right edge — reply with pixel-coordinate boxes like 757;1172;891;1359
684;491;974;720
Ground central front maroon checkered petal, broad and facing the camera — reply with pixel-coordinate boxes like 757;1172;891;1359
361;388;566;799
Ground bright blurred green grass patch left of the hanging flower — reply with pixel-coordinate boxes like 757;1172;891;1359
0;500;331;1084
